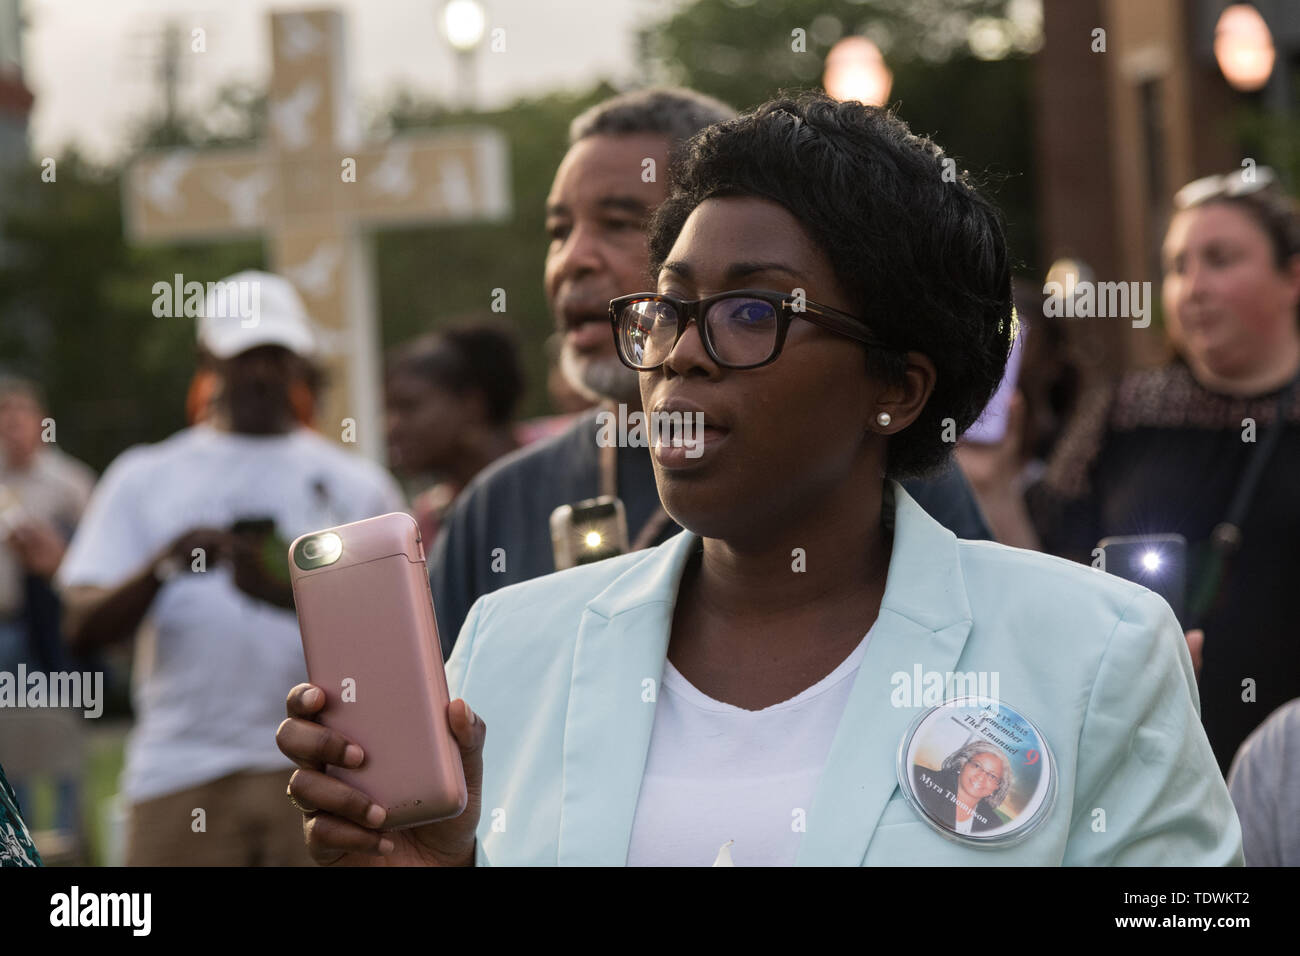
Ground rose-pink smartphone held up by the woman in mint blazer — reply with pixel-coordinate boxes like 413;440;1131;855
289;514;468;830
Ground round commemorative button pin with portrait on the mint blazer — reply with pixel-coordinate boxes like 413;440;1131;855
898;697;1057;847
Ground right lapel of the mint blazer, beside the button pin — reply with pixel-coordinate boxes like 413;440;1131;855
796;481;971;866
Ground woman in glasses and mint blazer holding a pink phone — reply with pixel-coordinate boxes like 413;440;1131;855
278;94;1240;866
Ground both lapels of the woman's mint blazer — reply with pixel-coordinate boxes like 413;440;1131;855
558;481;971;866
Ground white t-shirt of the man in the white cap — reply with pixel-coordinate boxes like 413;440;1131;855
56;425;403;801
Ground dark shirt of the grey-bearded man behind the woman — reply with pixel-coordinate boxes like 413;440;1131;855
429;410;993;658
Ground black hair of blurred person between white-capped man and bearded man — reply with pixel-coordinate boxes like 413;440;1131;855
387;319;524;425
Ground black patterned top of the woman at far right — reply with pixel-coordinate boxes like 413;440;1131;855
1026;360;1300;771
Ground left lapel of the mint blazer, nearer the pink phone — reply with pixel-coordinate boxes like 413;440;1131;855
558;532;698;866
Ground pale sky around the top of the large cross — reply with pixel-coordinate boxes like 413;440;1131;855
23;0;680;160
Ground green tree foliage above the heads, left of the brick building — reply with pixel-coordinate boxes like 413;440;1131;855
641;0;1040;274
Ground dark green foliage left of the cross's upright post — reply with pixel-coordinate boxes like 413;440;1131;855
0;152;261;470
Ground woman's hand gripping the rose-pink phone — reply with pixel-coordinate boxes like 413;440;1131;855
276;684;488;866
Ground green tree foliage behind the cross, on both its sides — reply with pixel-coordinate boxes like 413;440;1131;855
0;86;612;470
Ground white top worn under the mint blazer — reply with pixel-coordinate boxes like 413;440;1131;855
628;632;871;866
